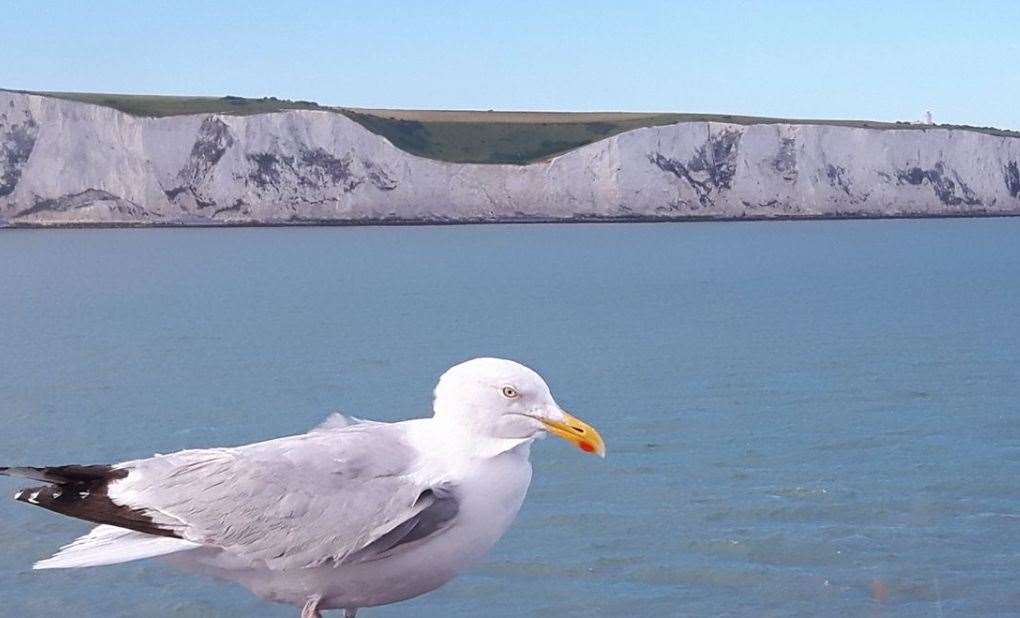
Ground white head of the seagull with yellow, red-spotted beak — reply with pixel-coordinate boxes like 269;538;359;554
434;358;606;457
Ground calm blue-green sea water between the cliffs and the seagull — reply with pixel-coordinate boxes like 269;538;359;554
0;219;1020;618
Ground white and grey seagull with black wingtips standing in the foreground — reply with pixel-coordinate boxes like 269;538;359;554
0;358;606;618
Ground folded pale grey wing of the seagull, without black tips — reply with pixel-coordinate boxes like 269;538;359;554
109;423;457;569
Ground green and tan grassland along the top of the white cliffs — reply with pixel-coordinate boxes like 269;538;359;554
9;92;1020;164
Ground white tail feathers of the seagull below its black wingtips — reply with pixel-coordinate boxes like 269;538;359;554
32;525;201;569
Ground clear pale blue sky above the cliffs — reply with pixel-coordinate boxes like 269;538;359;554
7;0;1020;130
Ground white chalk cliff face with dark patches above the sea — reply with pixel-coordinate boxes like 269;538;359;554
0;92;1020;224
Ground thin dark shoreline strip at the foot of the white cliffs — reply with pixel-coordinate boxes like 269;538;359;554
0;211;1020;231
